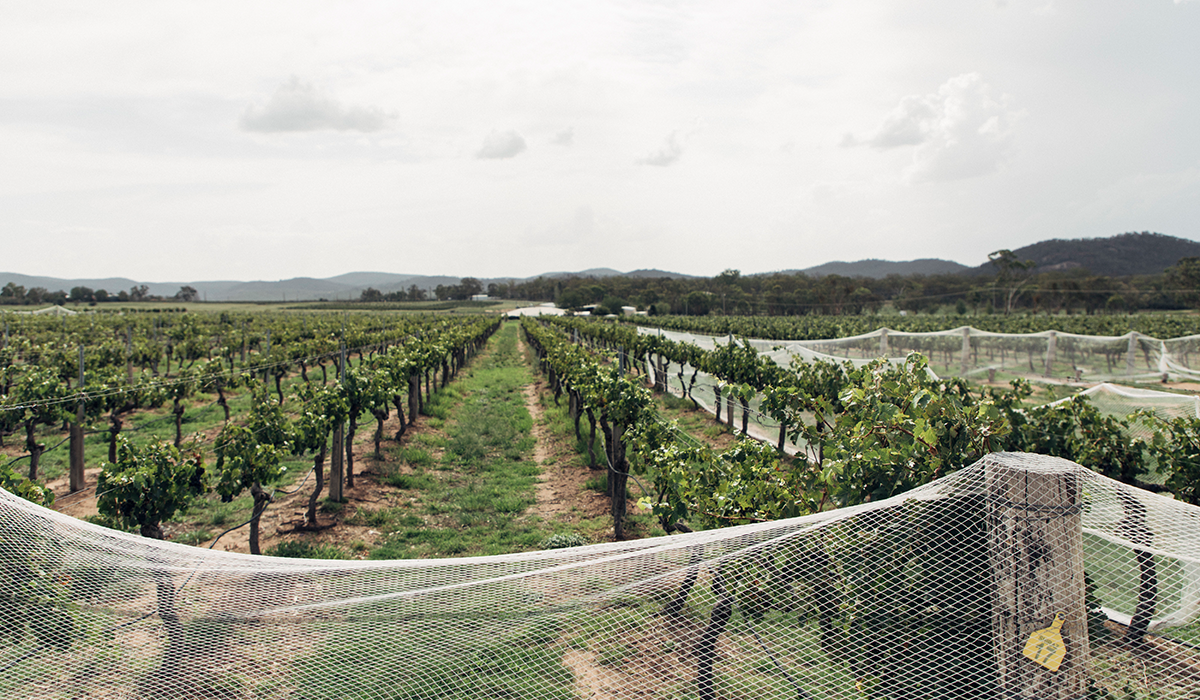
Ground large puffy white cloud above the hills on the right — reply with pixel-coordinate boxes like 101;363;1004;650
841;73;1022;183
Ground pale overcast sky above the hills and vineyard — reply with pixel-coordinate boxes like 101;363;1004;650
0;0;1200;282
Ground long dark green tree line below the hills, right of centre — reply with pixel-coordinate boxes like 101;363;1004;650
396;250;1200;316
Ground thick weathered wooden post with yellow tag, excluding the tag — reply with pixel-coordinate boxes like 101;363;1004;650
984;453;1088;700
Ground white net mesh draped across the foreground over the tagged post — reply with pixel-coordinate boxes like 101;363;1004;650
0;454;1200;700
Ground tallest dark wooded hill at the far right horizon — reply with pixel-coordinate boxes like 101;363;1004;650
976;231;1200;277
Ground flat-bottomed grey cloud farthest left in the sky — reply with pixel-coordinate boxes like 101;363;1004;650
240;76;391;133
